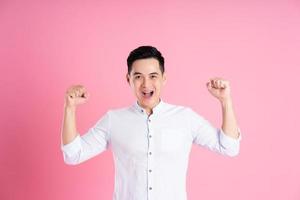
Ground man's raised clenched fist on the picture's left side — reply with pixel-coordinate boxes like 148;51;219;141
65;85;89;107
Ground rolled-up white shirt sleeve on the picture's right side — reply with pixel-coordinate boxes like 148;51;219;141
189;109;241;157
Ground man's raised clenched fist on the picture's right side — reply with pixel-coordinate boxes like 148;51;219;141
206;78;230;101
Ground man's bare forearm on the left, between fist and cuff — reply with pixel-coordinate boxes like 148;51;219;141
62;106;78;145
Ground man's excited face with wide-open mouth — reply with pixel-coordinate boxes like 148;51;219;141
127;58;166;113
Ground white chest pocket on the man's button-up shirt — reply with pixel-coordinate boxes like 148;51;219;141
161;130;185;153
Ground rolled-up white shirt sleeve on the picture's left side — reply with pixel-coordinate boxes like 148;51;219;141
61;112;110;165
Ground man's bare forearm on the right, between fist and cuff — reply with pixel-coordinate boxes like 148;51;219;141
221;98;239;139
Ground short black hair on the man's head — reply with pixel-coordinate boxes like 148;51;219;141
127;46;165;74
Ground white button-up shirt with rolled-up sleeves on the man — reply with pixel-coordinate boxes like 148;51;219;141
61;101;241;200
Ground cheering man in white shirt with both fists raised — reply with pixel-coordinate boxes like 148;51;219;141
62;46;241;200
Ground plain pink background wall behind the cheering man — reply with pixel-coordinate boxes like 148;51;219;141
0;0;300;200
